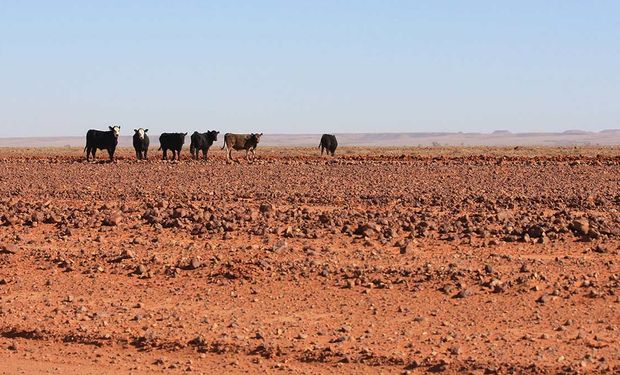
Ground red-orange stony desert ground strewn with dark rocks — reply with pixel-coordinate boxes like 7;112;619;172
0;148;620;374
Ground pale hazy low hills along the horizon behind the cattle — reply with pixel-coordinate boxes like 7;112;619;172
0;129;620;147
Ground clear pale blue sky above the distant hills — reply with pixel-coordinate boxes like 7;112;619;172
0;0;620;137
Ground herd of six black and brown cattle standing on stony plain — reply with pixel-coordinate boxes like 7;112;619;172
84;126;338;161
